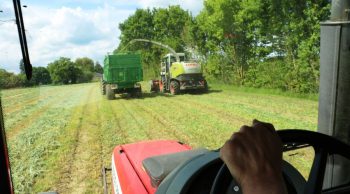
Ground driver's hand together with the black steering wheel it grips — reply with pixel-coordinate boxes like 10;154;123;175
211;121;350;194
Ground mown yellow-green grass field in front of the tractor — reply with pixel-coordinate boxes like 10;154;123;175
1;83;318;193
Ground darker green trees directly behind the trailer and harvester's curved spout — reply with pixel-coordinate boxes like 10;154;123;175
114;6;192;78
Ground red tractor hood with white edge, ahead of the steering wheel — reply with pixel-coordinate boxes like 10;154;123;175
111;140;191;194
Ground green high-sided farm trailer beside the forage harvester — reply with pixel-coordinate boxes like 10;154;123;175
101;53;143;100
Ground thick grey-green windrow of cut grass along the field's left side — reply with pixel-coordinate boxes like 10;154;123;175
9;84;93;193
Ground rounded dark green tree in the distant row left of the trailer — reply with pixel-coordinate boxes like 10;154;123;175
47;57;82;84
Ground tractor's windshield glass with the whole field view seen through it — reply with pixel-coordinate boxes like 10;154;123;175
0;0;330;193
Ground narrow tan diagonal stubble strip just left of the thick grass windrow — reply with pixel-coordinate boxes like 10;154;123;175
6;87;85;141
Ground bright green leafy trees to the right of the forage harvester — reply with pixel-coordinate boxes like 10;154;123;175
192;0;329;92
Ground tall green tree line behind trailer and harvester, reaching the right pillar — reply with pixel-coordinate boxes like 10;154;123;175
114;0;330;93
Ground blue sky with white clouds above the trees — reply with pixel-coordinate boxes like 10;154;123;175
0;0;203;73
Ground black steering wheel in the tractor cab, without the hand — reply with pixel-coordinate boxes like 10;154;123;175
210;129;350;194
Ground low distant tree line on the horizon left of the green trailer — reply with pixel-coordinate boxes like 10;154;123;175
0;57;103;88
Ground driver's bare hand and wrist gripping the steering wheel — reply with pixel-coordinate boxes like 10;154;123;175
220;120;287;194
